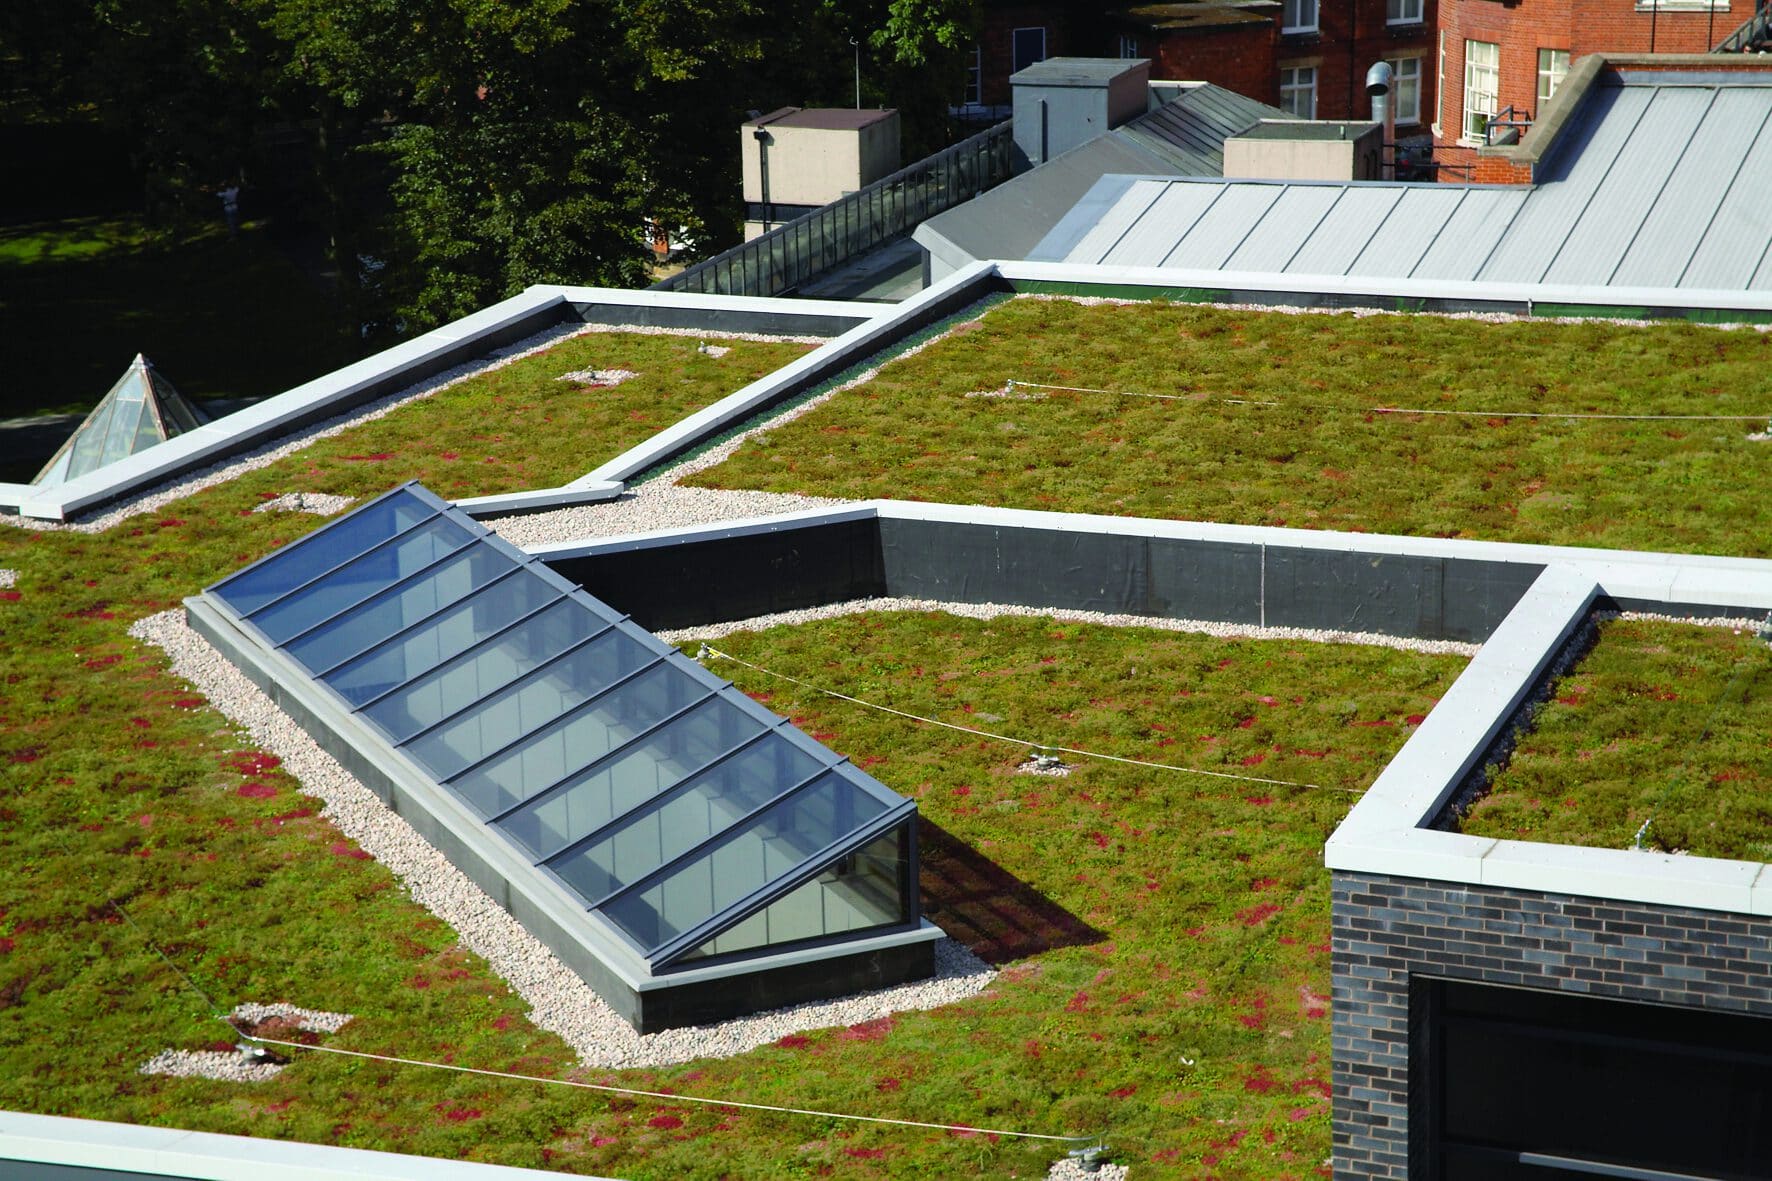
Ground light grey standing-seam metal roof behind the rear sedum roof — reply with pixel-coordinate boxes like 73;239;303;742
1031;73;1772;291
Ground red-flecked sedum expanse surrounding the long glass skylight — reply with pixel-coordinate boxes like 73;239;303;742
0;347;1462;1177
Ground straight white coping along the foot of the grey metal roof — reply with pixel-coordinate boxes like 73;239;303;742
998;259;1772;312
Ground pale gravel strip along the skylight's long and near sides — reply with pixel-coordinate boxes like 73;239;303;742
129;610;996;1068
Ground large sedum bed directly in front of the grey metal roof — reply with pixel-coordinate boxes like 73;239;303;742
691;298;1772;557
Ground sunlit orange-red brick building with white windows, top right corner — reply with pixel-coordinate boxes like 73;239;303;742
1428;0;1754;181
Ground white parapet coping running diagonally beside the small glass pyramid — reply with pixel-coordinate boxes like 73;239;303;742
0;289;565;521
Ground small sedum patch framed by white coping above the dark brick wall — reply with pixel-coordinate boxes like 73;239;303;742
1462;619;1772;862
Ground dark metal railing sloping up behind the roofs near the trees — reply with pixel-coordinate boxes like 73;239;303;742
652;121;1014;296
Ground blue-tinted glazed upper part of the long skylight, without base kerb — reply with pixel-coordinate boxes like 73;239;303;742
207;484;920;970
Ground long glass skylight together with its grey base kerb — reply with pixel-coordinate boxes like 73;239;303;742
188;484;939;1030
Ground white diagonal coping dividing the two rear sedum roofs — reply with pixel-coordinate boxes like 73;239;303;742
567;262;996;488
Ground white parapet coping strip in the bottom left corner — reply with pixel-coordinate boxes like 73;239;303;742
0;1112;620;1181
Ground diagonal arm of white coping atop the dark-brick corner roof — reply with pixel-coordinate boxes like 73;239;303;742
1324;566;1600;847
